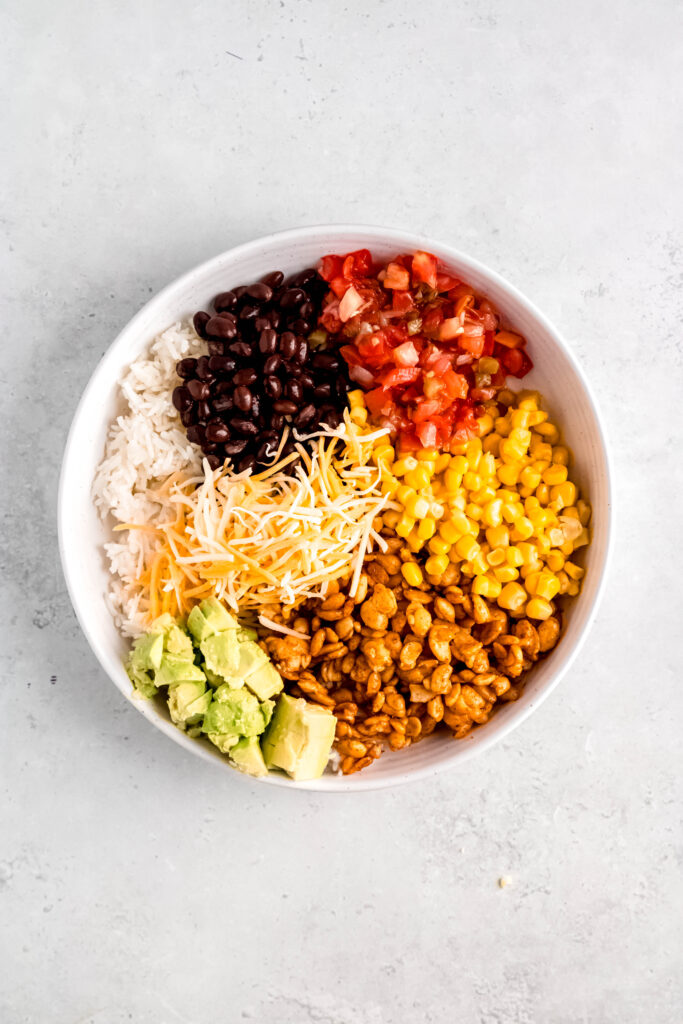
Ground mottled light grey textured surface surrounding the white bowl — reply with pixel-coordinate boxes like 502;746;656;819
0;0;683;1024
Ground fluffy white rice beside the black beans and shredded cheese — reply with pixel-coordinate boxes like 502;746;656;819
93;323;203;637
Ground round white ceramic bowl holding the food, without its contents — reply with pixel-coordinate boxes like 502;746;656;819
58;225;611;793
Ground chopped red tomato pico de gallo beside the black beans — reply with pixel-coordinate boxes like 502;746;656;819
319;249;532;451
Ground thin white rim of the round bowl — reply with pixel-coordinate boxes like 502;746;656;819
57;223;614;794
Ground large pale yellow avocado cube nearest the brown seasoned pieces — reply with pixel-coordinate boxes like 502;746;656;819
261;693;337;782
